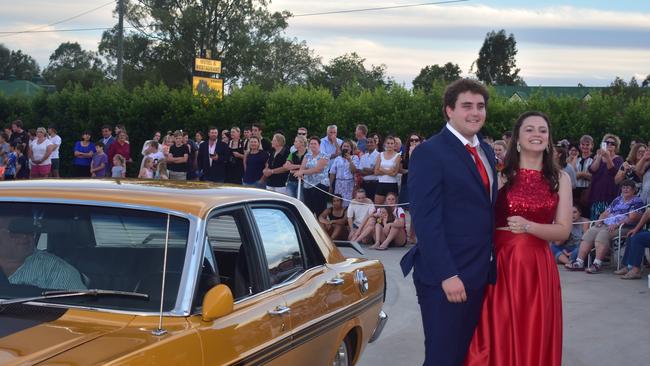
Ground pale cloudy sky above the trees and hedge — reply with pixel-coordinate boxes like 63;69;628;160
0;0;650;87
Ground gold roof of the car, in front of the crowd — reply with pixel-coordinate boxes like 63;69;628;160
0;179;290;217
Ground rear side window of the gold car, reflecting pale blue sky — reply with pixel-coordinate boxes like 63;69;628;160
253;208;305;286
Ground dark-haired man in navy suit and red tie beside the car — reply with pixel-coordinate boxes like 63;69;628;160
401;79;498;366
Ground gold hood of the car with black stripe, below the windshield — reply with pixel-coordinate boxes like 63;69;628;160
0;305;133;365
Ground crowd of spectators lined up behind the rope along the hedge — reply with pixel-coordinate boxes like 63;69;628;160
0;120;650;260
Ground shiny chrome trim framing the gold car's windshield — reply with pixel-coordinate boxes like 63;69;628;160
0;196;197;317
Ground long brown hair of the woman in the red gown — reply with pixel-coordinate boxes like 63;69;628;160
501;111;560;192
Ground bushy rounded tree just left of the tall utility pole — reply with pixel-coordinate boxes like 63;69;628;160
43;42;106;89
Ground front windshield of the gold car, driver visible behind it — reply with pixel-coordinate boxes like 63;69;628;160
0;202;189;312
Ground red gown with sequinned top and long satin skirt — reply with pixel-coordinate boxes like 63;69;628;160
465;169;562;366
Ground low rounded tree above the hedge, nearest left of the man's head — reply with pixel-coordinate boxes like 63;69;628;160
310;52;391;96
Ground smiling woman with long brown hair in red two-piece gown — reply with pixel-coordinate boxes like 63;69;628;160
465;112;572;366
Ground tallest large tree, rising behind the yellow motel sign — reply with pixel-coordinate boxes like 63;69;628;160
102;0;290;86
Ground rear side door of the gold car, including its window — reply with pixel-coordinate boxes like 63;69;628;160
251;205;353;365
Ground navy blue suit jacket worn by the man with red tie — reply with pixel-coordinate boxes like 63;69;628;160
400;127;498;289
